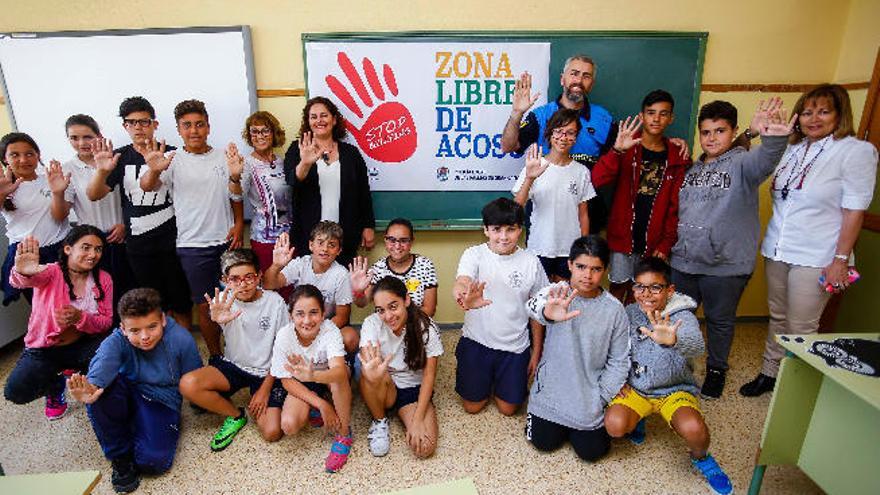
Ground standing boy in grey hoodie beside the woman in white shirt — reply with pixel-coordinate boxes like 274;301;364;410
670;100;794;399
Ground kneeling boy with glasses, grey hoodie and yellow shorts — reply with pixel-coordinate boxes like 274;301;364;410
605;257;733;494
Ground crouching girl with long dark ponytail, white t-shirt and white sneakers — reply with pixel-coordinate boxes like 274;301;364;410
360;276;443;458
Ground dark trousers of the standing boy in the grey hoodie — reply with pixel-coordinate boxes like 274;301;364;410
672;269;751;371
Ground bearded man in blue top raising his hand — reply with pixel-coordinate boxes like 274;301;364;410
501;55;617;233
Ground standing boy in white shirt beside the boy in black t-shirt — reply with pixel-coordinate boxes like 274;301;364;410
140;100;244;361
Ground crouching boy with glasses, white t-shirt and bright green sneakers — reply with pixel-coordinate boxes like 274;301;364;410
180;249;290;452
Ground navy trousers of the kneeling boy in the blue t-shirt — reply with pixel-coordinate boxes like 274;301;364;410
86;376;180;474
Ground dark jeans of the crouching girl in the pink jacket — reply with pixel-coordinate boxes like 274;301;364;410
3;335;104;404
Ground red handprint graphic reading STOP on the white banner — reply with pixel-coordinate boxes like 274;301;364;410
325;52;417;163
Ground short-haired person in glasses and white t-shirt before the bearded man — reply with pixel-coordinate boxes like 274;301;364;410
511;108;596;282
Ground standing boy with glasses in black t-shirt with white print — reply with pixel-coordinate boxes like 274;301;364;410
86;96;192;328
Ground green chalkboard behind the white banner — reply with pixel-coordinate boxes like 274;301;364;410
302;31;708;230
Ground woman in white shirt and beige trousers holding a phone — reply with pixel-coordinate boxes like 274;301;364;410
739;84;877;397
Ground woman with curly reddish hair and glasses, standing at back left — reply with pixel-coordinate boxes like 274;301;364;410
241;111;292;298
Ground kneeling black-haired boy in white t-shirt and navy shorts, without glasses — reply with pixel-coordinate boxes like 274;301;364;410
453;198;549;416
